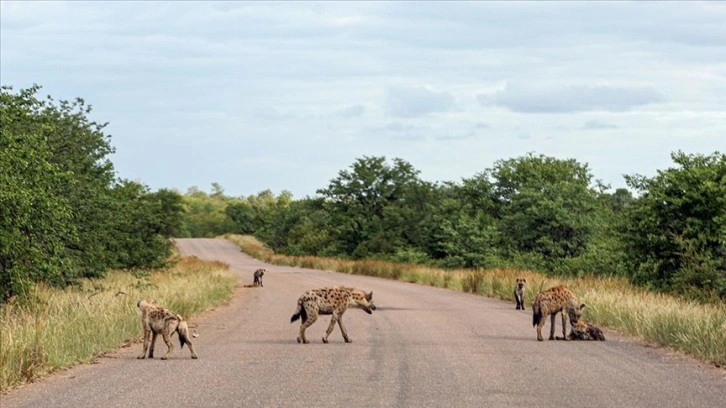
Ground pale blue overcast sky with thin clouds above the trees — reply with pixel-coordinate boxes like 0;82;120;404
0;0;726;198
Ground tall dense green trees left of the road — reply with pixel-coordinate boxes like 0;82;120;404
0;85;183;304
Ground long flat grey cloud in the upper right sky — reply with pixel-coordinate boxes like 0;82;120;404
477;85;663;113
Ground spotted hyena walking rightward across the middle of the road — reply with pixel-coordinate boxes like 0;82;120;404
290;286;376;343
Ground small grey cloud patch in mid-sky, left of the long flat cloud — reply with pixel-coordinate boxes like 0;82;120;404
386;87;454;118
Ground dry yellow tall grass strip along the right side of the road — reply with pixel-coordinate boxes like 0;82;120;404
225;235;726;366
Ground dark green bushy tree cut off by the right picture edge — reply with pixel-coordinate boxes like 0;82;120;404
621;151;726;298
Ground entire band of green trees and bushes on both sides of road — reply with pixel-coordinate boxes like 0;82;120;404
0;86;726;301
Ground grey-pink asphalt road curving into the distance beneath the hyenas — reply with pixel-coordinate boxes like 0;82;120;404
5;239;726;408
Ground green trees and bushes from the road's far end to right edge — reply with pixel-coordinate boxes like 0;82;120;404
184;152;726;303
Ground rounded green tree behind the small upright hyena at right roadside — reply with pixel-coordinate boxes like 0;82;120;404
488;154;597;267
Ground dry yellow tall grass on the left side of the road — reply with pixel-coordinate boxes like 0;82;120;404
0;258;237;392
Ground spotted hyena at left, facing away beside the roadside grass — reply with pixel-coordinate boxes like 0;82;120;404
136;300;197;360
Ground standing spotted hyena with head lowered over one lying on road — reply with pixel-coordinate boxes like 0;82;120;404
532;285;585;341
